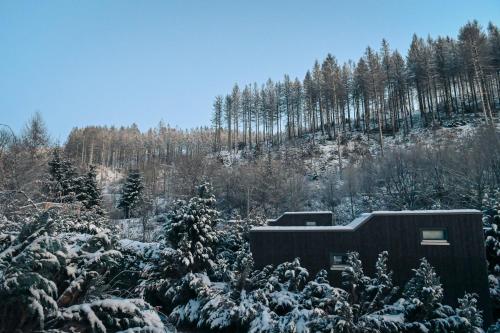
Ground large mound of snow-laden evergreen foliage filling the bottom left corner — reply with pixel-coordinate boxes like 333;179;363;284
0;209;170;332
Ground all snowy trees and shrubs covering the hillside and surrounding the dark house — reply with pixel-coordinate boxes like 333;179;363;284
0;18;500;333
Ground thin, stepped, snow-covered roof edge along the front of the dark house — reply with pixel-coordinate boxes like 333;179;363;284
252;209;481;232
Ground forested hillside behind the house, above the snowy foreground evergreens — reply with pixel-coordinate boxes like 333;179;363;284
0;21;500;222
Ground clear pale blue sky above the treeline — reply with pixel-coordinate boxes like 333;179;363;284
0;0;500;141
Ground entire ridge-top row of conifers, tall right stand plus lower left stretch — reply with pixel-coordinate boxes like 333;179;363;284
66;21;500;169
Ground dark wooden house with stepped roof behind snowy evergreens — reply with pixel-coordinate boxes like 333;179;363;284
250;210;491;321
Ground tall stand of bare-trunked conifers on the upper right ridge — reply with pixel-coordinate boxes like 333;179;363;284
213;21;500;151
